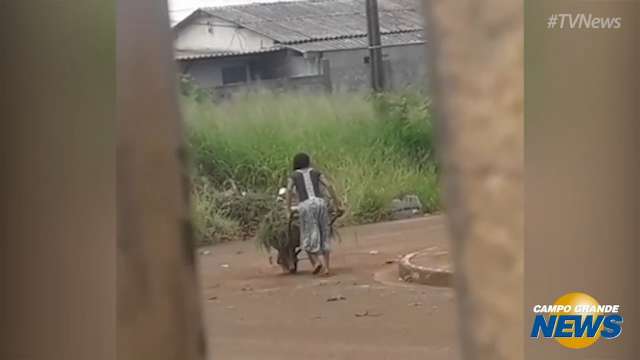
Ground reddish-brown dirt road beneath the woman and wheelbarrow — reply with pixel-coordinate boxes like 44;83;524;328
199;216;456;360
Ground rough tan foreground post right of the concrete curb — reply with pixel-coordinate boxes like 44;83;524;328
425;0;524;360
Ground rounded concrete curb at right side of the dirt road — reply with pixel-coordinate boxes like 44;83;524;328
398;247;453;287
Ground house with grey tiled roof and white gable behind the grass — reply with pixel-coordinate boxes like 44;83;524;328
173;0;427;96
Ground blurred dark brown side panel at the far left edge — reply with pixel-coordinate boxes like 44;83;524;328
0;0;116;360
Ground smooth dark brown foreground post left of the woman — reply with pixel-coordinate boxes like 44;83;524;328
117;0;206;360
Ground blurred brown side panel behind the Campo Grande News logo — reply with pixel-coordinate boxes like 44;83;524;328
524;0;640;360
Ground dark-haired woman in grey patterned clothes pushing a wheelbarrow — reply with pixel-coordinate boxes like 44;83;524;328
287;153;342;275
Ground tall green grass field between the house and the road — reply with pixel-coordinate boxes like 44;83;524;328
182;89;440;242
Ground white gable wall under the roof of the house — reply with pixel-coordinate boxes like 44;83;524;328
174;16;274;51
